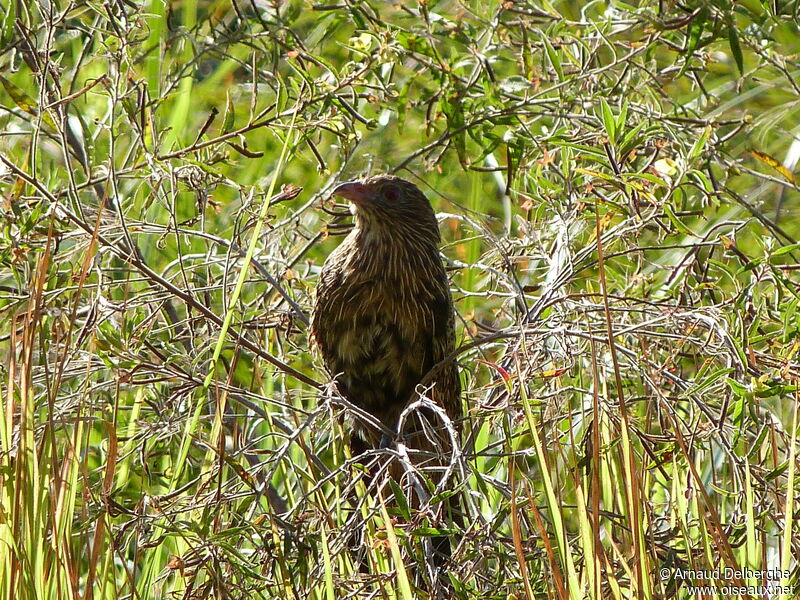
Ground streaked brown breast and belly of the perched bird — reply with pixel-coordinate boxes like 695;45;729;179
311;227;452;427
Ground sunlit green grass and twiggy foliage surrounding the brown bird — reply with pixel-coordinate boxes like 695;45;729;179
0;0;800;600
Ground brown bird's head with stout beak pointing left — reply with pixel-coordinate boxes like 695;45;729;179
333;175;439;244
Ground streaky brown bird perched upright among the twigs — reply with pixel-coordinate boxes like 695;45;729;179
311;175;462;464
